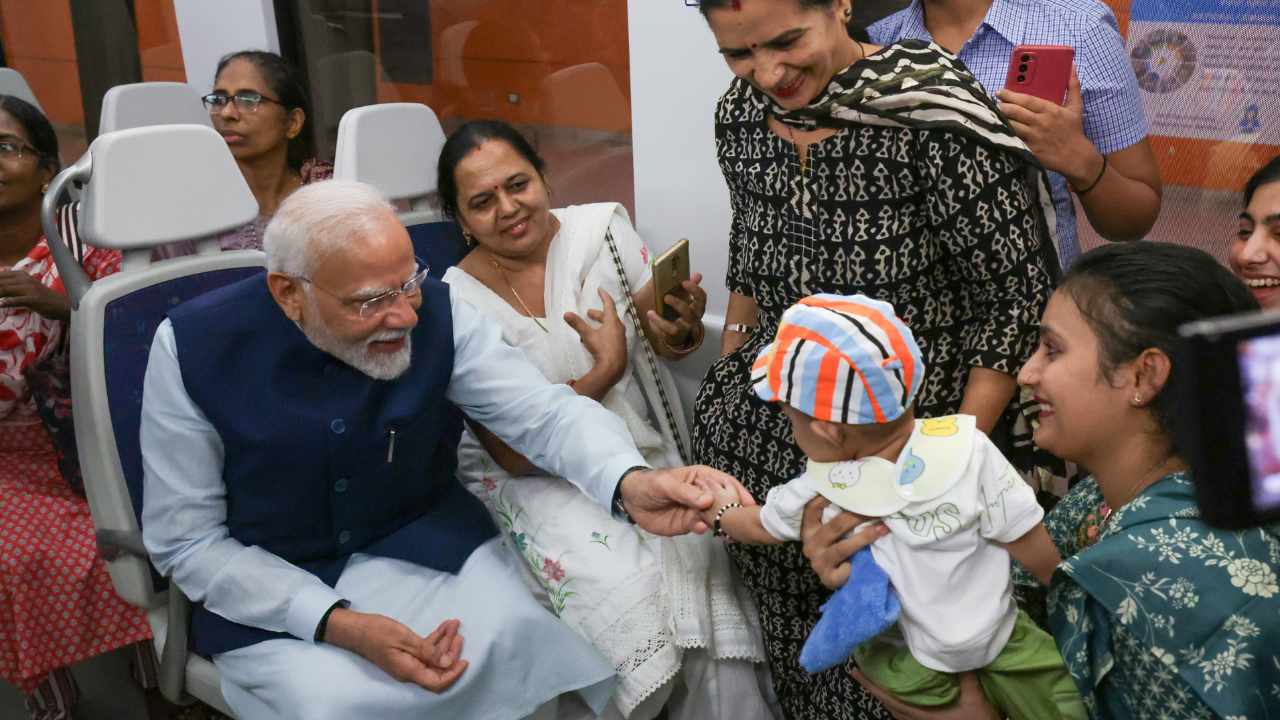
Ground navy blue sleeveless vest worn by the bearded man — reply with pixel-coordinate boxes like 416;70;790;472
169;273;498;655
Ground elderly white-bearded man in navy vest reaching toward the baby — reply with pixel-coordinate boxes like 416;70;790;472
141;181;750;720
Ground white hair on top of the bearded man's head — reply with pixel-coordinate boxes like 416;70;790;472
262;179;396;277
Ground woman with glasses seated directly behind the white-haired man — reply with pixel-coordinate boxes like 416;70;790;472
155;50;333;259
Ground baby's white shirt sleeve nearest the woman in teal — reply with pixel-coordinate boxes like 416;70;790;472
969;433;1044;542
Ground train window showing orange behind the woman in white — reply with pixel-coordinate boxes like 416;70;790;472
276;0;635;219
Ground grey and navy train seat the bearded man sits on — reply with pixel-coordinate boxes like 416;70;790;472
44;124;265;711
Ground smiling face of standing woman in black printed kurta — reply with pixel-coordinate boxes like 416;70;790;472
707;0;860;110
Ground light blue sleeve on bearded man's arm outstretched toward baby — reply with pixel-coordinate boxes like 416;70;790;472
449;287;649;509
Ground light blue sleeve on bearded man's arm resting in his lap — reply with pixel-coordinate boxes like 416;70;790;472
141;320;343;642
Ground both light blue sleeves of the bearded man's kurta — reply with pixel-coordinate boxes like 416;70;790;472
141;288;648;642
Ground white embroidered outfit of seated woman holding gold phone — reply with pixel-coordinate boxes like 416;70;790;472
444;204;764;720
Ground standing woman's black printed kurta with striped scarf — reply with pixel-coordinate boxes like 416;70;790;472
694;0;1056;720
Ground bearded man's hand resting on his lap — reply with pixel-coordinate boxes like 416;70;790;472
324;607;467;693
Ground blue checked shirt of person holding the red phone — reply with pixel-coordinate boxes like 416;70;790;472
867;0;1147;268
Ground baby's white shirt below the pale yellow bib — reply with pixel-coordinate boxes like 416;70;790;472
760;432;1044;673
